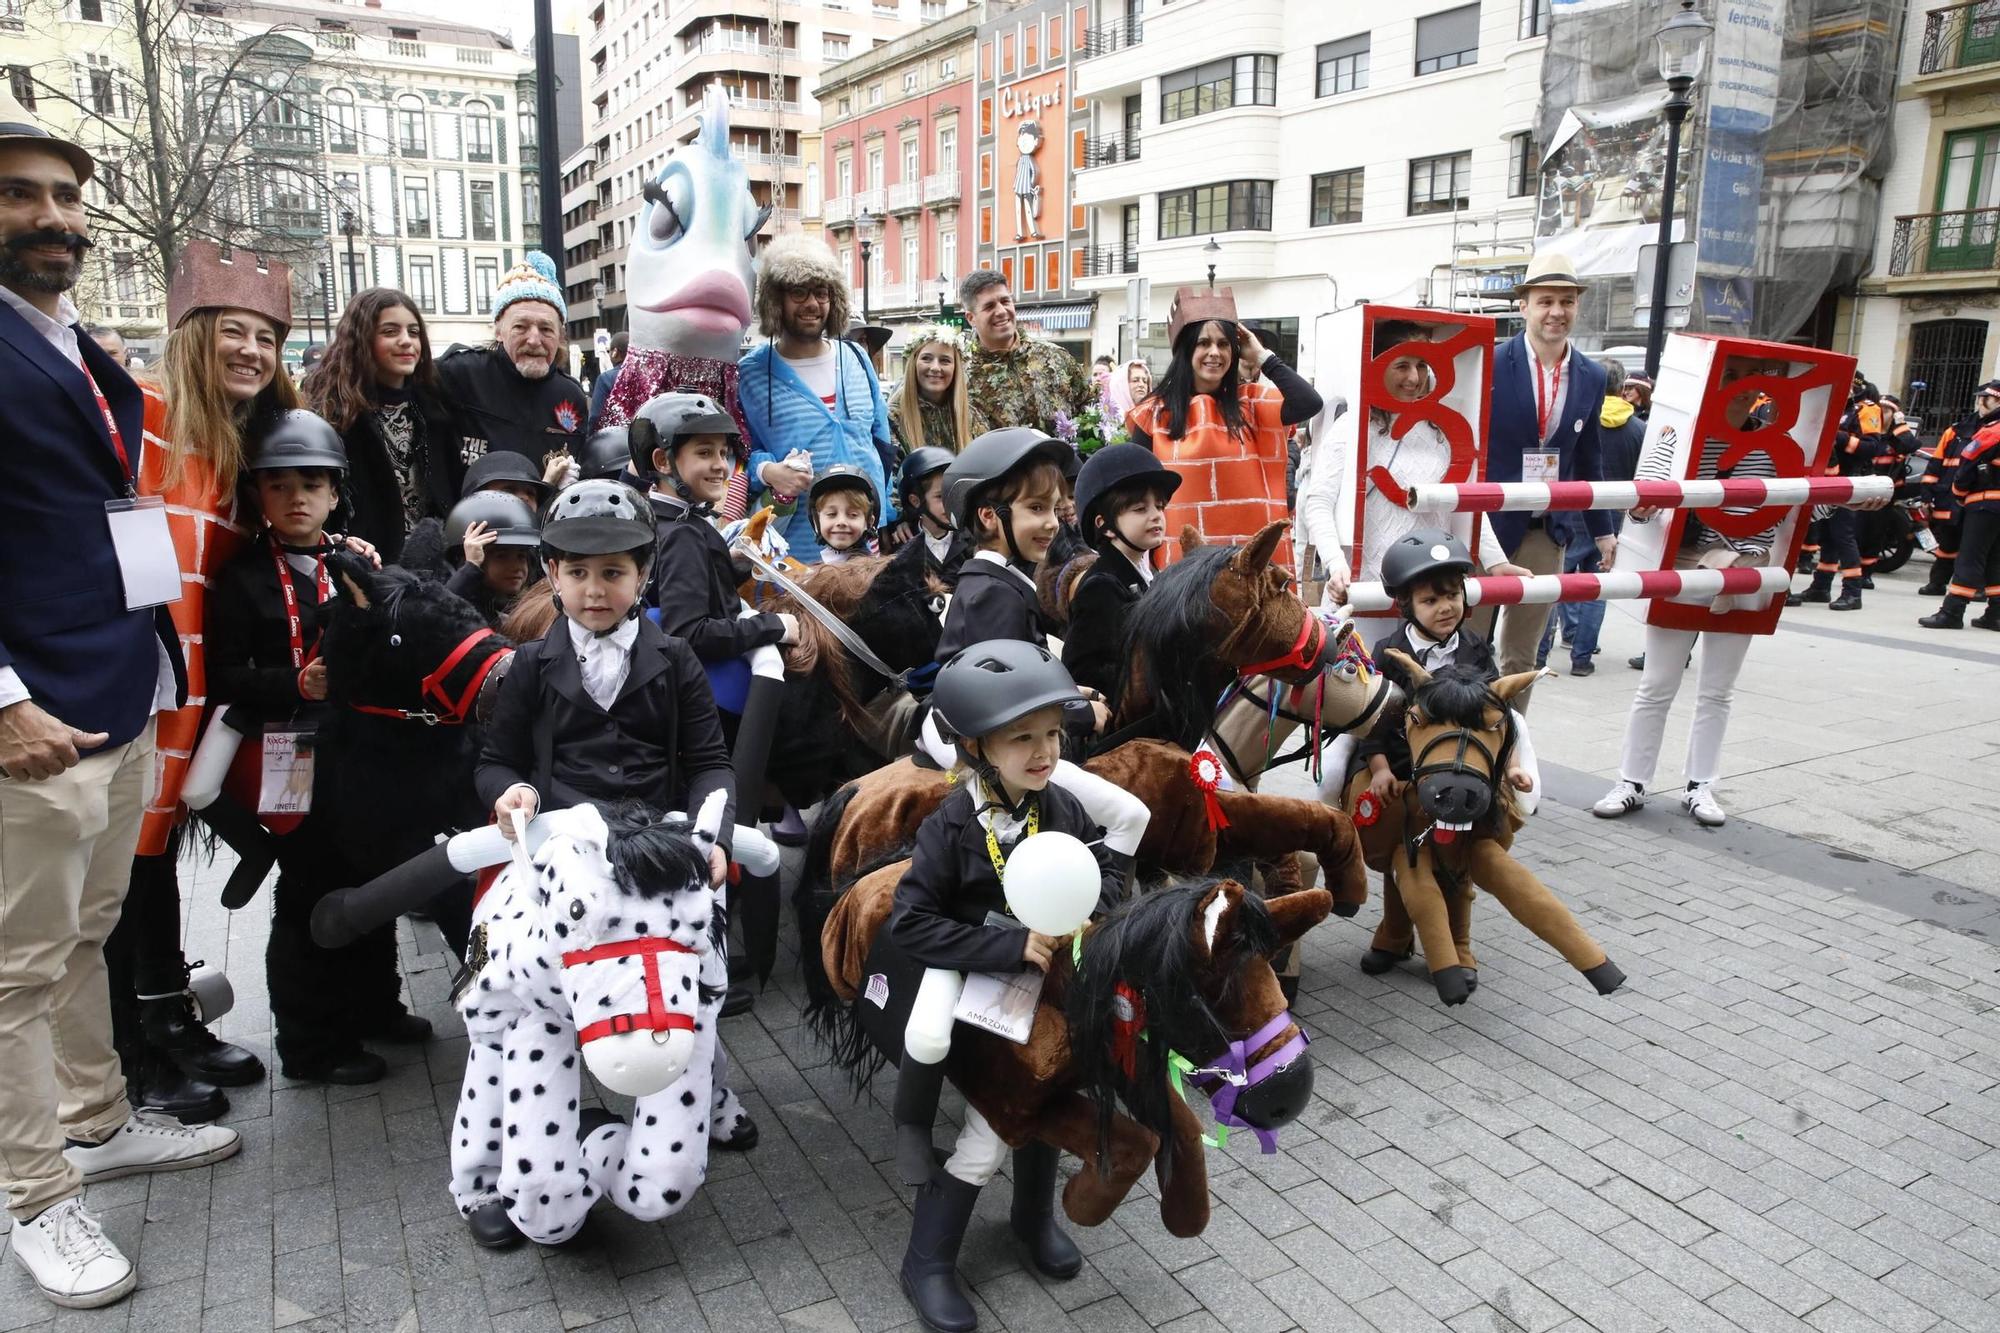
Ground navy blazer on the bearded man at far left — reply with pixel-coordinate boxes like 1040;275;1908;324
0;302;188;749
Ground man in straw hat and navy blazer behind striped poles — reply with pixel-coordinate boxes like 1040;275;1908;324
1486;250;1618;709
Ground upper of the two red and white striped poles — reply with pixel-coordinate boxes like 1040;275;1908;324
1408;476;1896;514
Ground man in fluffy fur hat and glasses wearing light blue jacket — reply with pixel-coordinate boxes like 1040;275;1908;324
736;236;896;560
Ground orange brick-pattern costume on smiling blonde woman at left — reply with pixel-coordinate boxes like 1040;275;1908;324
138;384;250;857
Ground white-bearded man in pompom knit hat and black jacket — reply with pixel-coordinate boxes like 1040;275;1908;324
438;250;590;476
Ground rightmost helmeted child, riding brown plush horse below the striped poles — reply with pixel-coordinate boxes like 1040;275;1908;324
1358;528;1540;813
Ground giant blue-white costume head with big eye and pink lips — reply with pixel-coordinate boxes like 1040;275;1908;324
602;84;770;516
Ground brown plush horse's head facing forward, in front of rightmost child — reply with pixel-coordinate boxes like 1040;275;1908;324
1388;648;1540;843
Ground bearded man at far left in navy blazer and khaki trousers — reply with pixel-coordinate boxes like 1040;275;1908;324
0;90;242;1307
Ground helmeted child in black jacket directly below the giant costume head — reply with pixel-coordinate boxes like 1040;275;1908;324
628;392;798;662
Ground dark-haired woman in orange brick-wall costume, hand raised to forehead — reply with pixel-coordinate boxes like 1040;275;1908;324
1126;286;1322;564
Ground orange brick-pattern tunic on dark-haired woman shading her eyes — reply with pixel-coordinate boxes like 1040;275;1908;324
1126;384;1292;566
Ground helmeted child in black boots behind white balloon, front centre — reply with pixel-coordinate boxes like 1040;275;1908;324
888;640;1136;1329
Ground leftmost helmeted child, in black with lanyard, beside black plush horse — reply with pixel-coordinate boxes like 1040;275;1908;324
204;408;410;1083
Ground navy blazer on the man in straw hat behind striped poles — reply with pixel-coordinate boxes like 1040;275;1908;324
1486;334;1612;556
